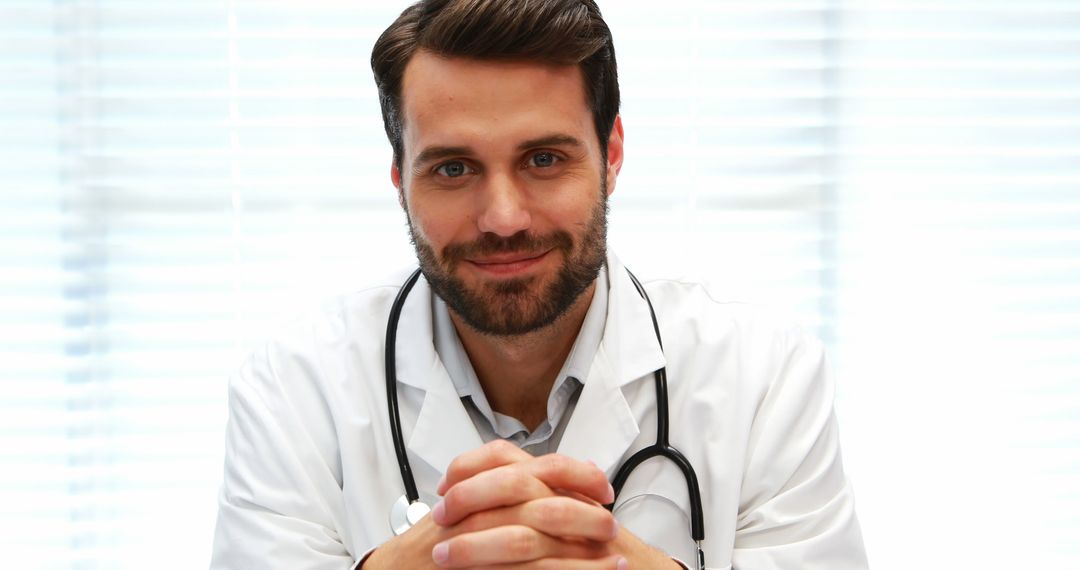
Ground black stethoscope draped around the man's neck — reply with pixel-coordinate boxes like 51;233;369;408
386;269;705;570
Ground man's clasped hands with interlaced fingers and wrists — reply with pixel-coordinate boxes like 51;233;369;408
362;439;679;570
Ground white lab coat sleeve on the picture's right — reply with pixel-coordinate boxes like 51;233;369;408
732;330;867;570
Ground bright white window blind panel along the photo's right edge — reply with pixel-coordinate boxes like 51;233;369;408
835;1;1080;568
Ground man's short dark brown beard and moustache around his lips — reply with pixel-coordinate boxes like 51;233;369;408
405;186;608;337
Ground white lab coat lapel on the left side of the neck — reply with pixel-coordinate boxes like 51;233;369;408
396;269;484;474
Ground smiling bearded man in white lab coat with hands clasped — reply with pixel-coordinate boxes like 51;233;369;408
213;0;866;570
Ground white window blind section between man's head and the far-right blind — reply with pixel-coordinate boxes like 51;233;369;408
602;1;836;337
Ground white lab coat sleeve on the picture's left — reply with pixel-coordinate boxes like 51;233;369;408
211;341;355;570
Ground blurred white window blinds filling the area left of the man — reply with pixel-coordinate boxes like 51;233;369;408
0;1;409;568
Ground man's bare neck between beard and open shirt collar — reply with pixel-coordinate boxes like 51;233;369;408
450;282;596;431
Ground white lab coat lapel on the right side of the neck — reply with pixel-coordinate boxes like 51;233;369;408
558;255;665;477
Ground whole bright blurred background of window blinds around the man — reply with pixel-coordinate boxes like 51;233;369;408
0;0;1080;570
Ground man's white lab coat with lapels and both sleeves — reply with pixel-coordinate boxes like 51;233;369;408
212;256;867;570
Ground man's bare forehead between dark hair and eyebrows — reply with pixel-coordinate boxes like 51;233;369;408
402;50;594;154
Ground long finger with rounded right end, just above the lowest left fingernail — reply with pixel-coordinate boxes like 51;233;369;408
454;497;619;542
